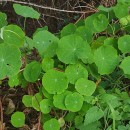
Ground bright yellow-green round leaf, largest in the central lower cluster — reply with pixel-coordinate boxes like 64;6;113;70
42;70;68;94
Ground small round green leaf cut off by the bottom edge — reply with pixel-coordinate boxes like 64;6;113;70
43;118;60;130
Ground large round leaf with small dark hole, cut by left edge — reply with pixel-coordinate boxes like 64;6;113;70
0;43;21;79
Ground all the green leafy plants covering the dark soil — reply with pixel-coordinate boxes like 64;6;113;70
0;0;130;130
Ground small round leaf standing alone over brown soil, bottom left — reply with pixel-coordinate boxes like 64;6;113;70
11;111;25;128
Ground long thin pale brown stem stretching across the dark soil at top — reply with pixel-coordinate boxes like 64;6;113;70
2;0;96;14
